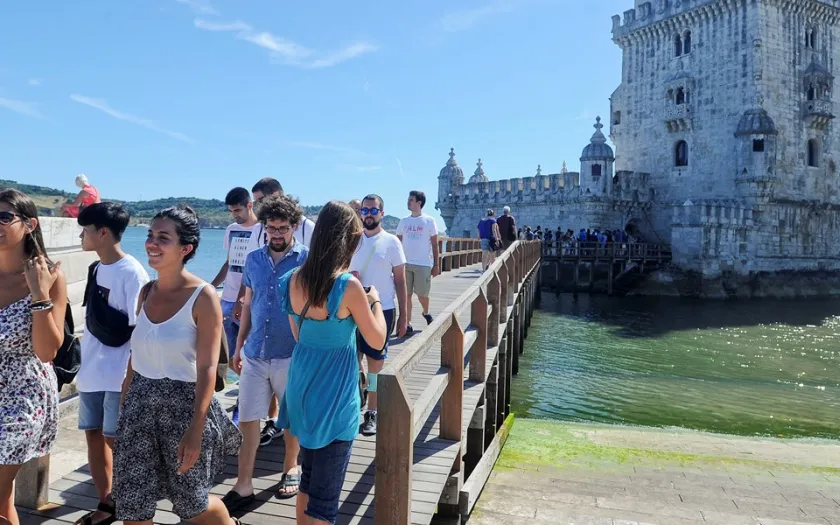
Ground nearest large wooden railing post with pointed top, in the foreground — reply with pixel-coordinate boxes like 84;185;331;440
373;372;414;525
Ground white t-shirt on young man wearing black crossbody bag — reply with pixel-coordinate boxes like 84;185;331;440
76;255;149;392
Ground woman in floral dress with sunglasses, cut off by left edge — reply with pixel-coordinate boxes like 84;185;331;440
0;190;67;525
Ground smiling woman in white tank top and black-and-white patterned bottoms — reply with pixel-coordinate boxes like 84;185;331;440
113;208;242;525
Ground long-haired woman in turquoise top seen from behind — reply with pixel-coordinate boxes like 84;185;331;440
278;201;386;525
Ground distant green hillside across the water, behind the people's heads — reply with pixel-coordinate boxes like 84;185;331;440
0;179;400;230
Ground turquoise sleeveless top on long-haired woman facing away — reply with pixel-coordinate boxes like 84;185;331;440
277;270;361;449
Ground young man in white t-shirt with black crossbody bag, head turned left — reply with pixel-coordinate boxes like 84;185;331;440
76;202;149;524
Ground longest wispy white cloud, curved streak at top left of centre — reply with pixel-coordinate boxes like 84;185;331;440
193;18;379;69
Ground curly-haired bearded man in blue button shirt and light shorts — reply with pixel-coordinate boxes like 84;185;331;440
222;194;309;511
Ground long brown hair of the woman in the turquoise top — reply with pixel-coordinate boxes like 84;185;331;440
298;201;362;307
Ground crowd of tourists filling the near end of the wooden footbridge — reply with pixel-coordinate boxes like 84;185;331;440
0;178;440;525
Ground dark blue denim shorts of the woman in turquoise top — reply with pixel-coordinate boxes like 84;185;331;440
300;441;353;524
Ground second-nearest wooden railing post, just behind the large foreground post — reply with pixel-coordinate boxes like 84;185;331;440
440;314;464;442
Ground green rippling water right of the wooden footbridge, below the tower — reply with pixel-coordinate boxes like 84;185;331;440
512;293;840;438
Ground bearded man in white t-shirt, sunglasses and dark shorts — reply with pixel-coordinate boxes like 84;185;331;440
350;195;407;436
